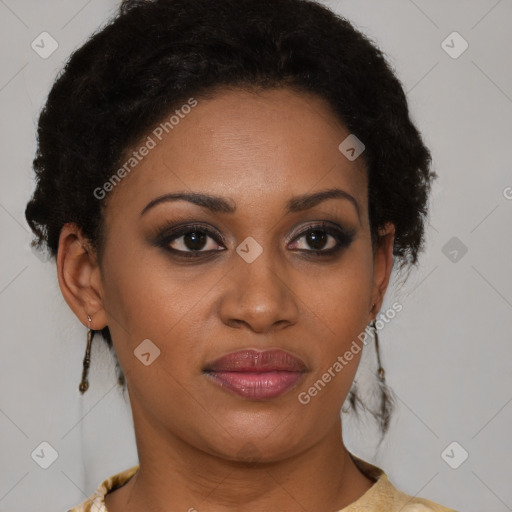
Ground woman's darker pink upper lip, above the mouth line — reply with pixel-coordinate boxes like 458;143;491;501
204;349;307;372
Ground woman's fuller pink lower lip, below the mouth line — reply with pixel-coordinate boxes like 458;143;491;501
207;371;304;400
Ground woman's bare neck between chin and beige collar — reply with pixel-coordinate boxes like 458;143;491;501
105;402;373;512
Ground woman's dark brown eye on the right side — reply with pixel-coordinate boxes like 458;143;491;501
293;223;354;255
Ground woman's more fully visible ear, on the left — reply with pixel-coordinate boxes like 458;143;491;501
56;223;107;330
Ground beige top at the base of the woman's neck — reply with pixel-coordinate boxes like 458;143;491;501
67;452;457;512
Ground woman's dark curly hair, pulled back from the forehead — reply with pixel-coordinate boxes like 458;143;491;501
25;0;436;442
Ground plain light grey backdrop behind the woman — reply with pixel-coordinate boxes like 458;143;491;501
0;0;512;512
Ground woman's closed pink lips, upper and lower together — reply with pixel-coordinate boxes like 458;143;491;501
203;349;308;400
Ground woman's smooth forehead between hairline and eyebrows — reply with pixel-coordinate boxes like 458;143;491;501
105;88;367;222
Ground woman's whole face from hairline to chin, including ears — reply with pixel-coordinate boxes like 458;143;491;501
58;89;393;460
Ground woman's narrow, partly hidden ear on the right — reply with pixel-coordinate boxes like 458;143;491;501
370;222;395;321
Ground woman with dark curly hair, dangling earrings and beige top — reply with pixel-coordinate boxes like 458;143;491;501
26;0;458;512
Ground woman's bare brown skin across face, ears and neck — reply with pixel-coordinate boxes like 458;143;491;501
57;89;394;512
